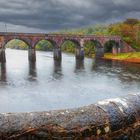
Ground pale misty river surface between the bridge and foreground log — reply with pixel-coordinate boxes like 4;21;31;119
0;49;140;112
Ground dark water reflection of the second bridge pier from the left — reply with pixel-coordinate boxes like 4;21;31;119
29;62;37;80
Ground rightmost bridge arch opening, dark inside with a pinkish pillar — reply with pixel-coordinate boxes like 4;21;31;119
104;40;120;54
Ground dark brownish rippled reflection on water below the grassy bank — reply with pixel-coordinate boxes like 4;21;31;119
91;59;140;83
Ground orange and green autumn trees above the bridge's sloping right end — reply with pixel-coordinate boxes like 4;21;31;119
108;19;140;51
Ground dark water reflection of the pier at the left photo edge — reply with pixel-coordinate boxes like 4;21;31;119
0;63;6;82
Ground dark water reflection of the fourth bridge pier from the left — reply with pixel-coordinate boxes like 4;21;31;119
75;59;85;72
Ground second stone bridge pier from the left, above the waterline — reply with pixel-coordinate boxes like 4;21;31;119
28;48;36;62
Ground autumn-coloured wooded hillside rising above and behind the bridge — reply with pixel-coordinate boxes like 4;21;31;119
58;18;140;53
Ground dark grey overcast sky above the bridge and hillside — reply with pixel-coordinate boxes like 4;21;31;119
0;0;140;32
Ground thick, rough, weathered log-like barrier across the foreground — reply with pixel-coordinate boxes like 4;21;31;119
0;94;140;140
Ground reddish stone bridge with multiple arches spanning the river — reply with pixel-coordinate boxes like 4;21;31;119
0;32;133;62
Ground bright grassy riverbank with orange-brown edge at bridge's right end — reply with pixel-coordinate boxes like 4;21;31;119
103;52;140;63
